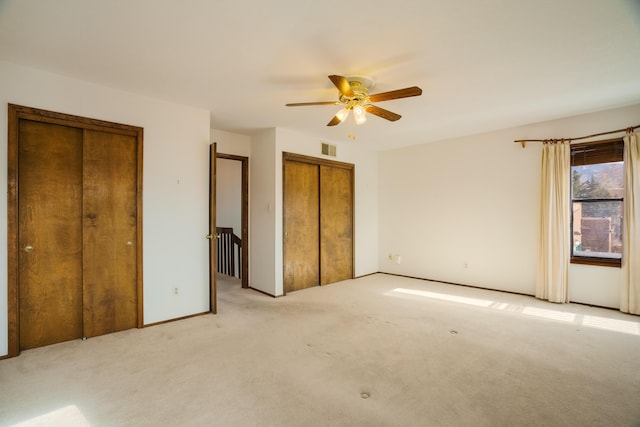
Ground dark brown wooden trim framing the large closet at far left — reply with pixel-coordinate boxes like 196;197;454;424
7;104;144;357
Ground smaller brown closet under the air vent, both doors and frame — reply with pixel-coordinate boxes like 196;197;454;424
283;153;354;292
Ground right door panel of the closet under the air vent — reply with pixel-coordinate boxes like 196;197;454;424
320;165;353;285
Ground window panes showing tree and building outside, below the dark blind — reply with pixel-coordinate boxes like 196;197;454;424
571;162;624;259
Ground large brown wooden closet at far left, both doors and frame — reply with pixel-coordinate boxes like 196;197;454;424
7;104;143;357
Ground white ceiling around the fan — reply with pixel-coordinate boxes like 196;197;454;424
0;0;640;149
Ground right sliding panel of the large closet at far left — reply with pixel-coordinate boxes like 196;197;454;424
82;130;138;337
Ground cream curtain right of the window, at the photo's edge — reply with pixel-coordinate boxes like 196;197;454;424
620;133;640;314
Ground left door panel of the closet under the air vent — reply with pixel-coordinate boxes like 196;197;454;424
283;161;320;292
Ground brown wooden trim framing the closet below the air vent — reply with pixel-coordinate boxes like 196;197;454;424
282;151;356;295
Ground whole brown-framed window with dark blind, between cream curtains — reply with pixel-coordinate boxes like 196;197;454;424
571;139;624;266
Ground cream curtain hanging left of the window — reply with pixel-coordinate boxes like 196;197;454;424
536;141;571;303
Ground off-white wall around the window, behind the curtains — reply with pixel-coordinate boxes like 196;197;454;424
378;105;640;308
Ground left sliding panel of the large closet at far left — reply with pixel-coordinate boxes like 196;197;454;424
18;120;83;349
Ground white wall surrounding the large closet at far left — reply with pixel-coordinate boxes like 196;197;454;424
0;61;210;355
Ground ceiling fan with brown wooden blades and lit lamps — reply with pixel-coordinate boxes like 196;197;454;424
286;75;422;126
